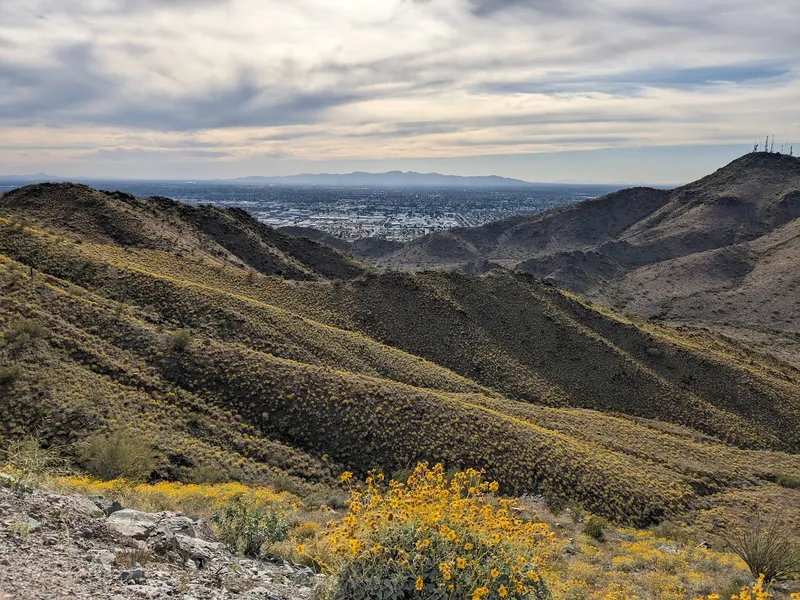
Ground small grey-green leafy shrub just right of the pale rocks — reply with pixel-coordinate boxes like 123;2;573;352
211;497;289;556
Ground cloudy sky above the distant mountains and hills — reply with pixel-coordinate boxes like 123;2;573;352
0;0;800;184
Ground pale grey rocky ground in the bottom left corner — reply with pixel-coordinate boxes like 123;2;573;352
0;476;320;600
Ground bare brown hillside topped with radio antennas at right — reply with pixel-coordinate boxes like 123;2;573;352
372;153;800;365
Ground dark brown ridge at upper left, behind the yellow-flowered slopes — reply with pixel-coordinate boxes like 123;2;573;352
0;183;364;279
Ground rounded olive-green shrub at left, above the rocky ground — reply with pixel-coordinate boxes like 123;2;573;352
78;431;158;481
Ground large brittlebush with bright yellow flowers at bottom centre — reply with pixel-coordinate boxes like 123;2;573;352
312;464;555;600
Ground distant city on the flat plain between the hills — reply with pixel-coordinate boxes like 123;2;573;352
0;180;619;242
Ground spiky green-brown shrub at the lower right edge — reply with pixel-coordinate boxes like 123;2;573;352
725;519;800;581
